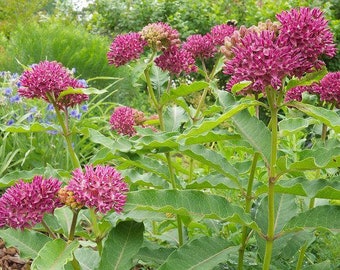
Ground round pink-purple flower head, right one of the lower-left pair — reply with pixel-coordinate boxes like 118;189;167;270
66;165;128;214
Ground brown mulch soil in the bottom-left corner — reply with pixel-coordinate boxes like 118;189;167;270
0;238;31;270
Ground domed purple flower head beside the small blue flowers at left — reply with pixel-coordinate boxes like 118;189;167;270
18;61;88;109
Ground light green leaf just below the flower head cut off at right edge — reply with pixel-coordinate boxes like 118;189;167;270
289;101;340;133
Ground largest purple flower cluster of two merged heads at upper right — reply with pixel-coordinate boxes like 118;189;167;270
222;8;336;92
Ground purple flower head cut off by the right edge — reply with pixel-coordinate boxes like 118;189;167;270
313;71;340;108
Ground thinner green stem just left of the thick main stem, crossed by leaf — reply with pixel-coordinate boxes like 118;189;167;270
237;152;260;270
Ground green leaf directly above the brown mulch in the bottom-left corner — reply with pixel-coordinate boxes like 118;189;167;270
0;228;51;259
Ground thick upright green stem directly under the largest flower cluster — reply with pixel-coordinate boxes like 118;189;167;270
263;88;278;270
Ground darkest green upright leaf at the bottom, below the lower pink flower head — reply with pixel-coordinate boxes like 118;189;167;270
98;221;144;270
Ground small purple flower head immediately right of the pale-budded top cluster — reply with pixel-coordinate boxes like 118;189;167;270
182;34;217;59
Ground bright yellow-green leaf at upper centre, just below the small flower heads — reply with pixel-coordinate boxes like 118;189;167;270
159;81;209;105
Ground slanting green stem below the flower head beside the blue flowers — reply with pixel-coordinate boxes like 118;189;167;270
46;93;81;168
